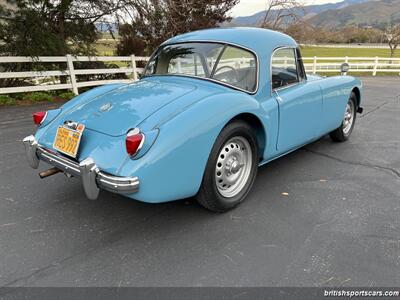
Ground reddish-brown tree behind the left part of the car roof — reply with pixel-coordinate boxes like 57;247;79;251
117;0;239;55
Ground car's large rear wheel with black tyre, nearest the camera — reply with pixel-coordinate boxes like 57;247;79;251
196;120;259;212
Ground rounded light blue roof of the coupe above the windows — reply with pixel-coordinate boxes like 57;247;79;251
163;27;297;55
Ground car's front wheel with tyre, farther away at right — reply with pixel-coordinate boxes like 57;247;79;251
329;93;357;142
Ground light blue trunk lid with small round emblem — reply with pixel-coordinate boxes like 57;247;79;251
60;80;196;136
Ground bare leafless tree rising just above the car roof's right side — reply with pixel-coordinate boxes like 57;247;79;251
261;0;304;30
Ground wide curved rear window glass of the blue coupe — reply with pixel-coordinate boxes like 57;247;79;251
144;43;257;92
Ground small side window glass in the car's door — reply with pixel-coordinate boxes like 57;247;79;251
271;48;299;89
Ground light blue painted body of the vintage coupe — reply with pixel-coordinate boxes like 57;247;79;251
32;28;361;203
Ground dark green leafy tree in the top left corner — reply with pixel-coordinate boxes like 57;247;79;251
0;0;125;56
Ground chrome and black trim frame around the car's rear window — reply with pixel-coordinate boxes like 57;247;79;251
143;40;260;95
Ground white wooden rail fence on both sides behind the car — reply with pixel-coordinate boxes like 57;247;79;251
0;55;400;95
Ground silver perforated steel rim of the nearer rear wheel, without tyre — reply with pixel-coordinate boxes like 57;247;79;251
215;136;252;198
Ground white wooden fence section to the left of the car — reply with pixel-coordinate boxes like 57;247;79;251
0;55;148;95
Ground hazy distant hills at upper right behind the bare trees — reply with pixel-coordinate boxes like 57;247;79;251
231;0;400;27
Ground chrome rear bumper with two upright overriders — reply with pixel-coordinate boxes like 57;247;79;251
23;135;139;200
